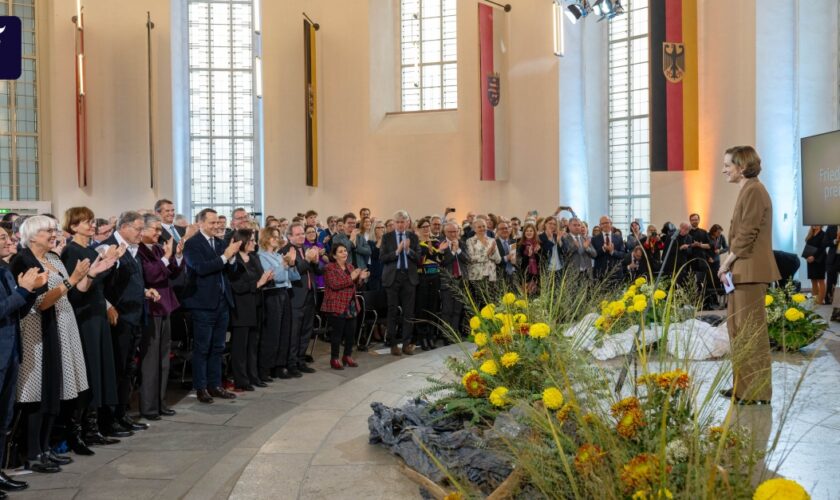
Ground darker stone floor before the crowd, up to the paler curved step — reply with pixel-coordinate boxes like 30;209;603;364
8;336;397;500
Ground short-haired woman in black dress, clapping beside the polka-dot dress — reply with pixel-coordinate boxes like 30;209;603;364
61;207;125;455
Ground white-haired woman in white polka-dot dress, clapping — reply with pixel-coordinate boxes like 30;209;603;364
10;215;115;472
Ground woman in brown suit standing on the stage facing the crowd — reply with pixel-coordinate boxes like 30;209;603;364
718;146;780;404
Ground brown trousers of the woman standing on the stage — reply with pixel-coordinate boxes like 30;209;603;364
726;283;773;401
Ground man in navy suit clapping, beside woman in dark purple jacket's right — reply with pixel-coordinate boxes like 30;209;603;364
183;208;241;403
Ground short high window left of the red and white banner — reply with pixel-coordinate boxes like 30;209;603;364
400;0;458;111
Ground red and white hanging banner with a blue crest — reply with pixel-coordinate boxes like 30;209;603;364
478;3;510;181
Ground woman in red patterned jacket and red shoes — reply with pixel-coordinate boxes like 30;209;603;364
321;243;370;370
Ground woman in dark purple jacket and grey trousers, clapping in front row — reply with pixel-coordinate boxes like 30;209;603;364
137;214;186;420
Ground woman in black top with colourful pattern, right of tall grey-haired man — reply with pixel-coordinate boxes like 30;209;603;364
412;217;443;351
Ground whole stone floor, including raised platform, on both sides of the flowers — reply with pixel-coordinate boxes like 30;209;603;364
12;307;840;499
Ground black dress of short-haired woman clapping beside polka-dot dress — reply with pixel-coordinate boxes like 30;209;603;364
61;241;117;409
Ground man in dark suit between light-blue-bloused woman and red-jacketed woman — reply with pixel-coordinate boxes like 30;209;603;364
280;222;321;373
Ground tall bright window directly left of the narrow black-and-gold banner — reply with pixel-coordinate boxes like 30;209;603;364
187;0;261;219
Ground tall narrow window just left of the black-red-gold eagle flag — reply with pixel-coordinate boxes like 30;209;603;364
608;0;650;233
